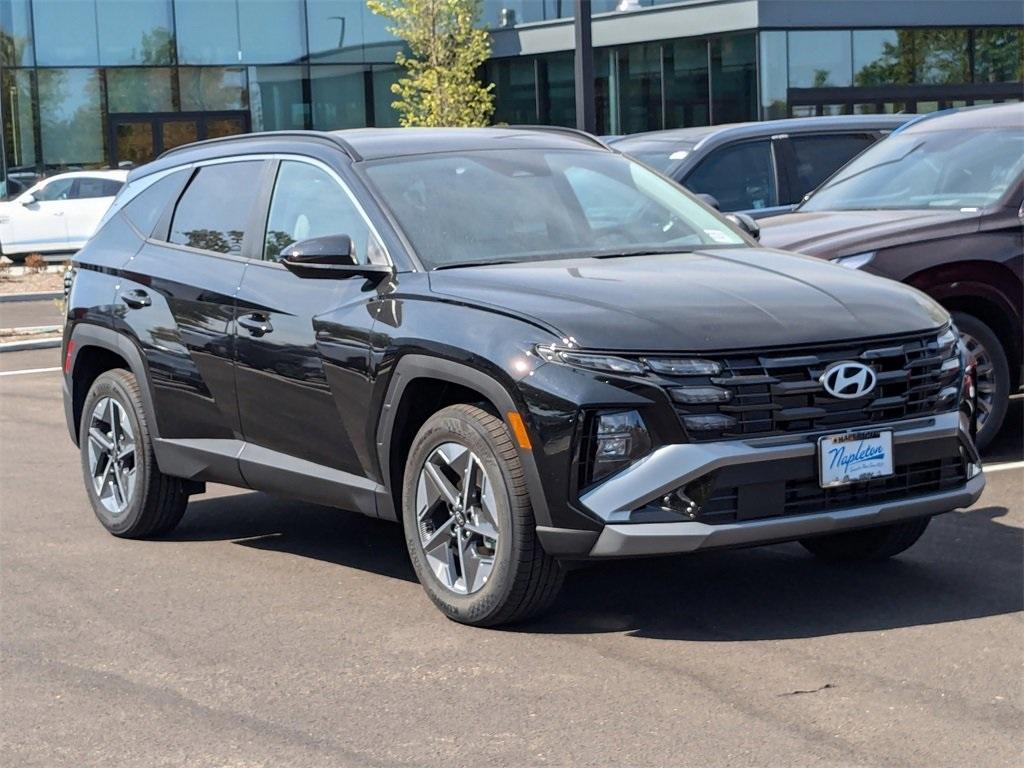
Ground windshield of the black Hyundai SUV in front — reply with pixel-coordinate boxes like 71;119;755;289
367;150;745;268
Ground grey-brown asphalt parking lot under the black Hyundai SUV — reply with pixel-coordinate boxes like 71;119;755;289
0;349;1024;768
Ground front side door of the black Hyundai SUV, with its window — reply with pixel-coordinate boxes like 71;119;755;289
236;160;384;495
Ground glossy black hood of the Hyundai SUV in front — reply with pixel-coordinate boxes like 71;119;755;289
430;248;947;351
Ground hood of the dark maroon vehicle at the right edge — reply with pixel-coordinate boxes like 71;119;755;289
758;211;979;259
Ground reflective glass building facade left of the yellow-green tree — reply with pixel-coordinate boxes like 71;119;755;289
0;0;407;188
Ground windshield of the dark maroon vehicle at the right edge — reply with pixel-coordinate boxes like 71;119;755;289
800;129;1024;211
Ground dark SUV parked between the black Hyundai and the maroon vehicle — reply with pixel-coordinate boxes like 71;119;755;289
611;115;915;218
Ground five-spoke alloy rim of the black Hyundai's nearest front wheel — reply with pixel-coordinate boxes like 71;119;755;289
416;442;499;595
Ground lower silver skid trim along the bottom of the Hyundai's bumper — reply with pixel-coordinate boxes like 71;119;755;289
590;474;985;557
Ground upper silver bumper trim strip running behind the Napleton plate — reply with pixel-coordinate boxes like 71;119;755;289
580;411;959;527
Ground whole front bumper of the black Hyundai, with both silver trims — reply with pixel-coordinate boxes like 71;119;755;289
538;411;985;558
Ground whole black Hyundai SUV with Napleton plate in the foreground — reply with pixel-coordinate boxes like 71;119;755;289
63;128;984;625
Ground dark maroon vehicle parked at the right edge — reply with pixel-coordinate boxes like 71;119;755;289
759;103;1024;446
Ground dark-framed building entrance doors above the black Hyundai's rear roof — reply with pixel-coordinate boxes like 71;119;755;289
110;112;249;168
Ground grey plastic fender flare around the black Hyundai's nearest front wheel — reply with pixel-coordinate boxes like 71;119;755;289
377;354;551;525
